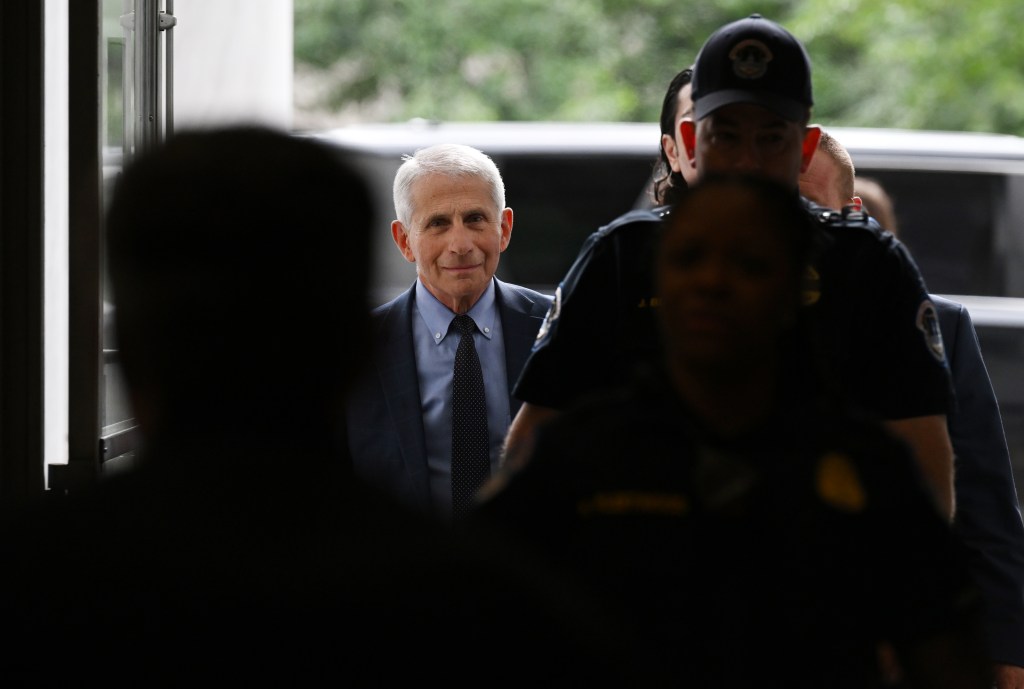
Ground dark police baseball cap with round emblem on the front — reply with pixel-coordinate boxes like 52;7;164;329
691;14;814;122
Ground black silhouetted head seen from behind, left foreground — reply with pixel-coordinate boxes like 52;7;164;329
108;127;374;440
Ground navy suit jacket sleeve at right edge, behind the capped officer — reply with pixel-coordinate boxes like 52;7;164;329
932;295;1024;666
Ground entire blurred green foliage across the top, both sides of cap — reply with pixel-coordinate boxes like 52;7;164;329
294;0;1024;134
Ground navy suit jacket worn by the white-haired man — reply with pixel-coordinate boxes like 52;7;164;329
345;278;552;511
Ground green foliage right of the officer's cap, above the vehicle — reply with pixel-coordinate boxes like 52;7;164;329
786;0;1024;134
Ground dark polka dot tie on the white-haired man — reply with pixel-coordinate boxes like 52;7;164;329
449;314;490;519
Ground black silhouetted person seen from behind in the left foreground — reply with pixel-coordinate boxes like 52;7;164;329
0;127;630;687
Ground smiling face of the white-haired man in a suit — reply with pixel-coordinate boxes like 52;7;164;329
391;174;512;313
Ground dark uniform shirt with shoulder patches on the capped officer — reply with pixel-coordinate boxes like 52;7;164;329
514;196;951;419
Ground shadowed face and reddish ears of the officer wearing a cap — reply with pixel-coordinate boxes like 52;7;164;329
680;103;820;187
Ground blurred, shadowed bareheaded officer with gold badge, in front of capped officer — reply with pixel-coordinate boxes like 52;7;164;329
475;175;988;689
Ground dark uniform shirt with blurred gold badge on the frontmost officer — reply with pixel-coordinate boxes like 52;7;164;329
477;378;977;689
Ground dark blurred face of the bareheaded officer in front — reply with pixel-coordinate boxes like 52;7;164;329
657;187;798;373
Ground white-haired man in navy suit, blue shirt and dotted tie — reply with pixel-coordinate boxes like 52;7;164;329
346;143;551;519
